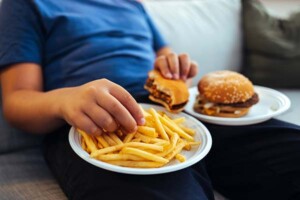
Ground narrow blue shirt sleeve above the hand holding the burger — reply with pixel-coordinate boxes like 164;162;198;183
145;6;167;52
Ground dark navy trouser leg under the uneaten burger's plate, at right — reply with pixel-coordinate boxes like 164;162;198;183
205;119;300;200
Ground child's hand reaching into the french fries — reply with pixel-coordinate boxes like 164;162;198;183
58;79;144;135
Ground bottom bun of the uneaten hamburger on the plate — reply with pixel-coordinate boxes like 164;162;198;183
194;103;251;118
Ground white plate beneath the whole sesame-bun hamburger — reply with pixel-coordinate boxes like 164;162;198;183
185;86;291;126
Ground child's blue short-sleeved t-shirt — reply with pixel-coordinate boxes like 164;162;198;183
0;0;165;93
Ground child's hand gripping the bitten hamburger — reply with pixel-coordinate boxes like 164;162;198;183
154;53;198;81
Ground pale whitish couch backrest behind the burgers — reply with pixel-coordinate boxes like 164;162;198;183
144;0;242;85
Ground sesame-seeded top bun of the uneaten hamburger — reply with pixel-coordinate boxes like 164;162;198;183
198;70;254;104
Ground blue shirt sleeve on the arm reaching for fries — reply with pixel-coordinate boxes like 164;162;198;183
0;0;44;69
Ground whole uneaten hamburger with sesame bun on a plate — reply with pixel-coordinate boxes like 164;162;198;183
194;70;259;118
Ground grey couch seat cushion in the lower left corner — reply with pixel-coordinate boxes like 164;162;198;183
0;148;66;200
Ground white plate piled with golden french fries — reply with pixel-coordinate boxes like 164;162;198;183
69;104;212;175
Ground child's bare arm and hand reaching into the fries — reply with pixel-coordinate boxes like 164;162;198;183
1;63;143;133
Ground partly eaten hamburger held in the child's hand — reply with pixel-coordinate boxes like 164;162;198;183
144;70;189;113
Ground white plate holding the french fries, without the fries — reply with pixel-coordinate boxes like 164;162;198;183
69;104;212;175
